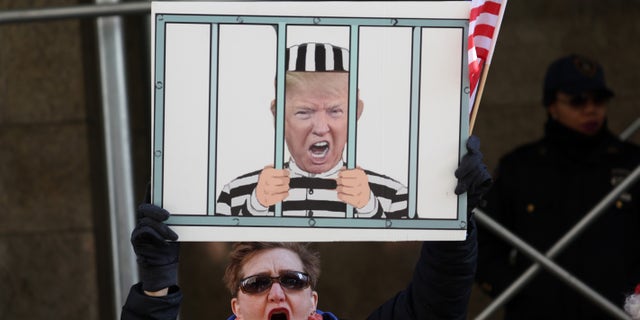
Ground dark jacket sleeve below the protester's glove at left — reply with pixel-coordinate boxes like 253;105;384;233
120;283;182;320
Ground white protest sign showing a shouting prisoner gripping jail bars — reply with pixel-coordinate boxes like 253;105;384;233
151;1;470;241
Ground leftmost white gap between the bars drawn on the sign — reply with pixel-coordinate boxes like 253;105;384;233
162;23;211;215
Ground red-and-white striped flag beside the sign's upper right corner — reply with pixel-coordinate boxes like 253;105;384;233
468;0;507;119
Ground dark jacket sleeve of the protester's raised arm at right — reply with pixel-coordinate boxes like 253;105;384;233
368;217;478;320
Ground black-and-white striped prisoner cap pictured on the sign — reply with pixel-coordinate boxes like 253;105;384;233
284;42;349;72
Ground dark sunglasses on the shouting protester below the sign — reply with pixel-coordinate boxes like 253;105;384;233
240;271;311;294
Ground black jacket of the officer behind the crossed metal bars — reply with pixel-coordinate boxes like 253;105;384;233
477;119;640;319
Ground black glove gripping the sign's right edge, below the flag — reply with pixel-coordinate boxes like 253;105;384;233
455;136;492;213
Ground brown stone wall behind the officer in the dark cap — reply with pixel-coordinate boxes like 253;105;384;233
475;0;640;172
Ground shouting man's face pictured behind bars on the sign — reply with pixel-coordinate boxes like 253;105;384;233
284;72;362;173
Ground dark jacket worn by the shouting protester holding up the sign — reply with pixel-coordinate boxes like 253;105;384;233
121;218;477;320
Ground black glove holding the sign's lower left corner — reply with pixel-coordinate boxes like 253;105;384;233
131;203;180;291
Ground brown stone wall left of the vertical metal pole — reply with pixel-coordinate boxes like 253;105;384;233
0;1;99;319
